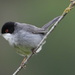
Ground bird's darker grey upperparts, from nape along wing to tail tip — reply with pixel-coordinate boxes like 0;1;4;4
16;16;60;34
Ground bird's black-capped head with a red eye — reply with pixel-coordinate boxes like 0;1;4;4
1;22;15;34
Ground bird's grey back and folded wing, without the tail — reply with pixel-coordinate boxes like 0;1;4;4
16;22;47;34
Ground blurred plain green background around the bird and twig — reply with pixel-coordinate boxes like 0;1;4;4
0;0;75;75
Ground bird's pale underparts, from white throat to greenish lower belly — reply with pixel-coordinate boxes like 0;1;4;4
3;33;43;56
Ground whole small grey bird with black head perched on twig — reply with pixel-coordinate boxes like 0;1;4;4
1;16;60;57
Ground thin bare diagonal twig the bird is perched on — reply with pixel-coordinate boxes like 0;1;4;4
13;0;75;75
